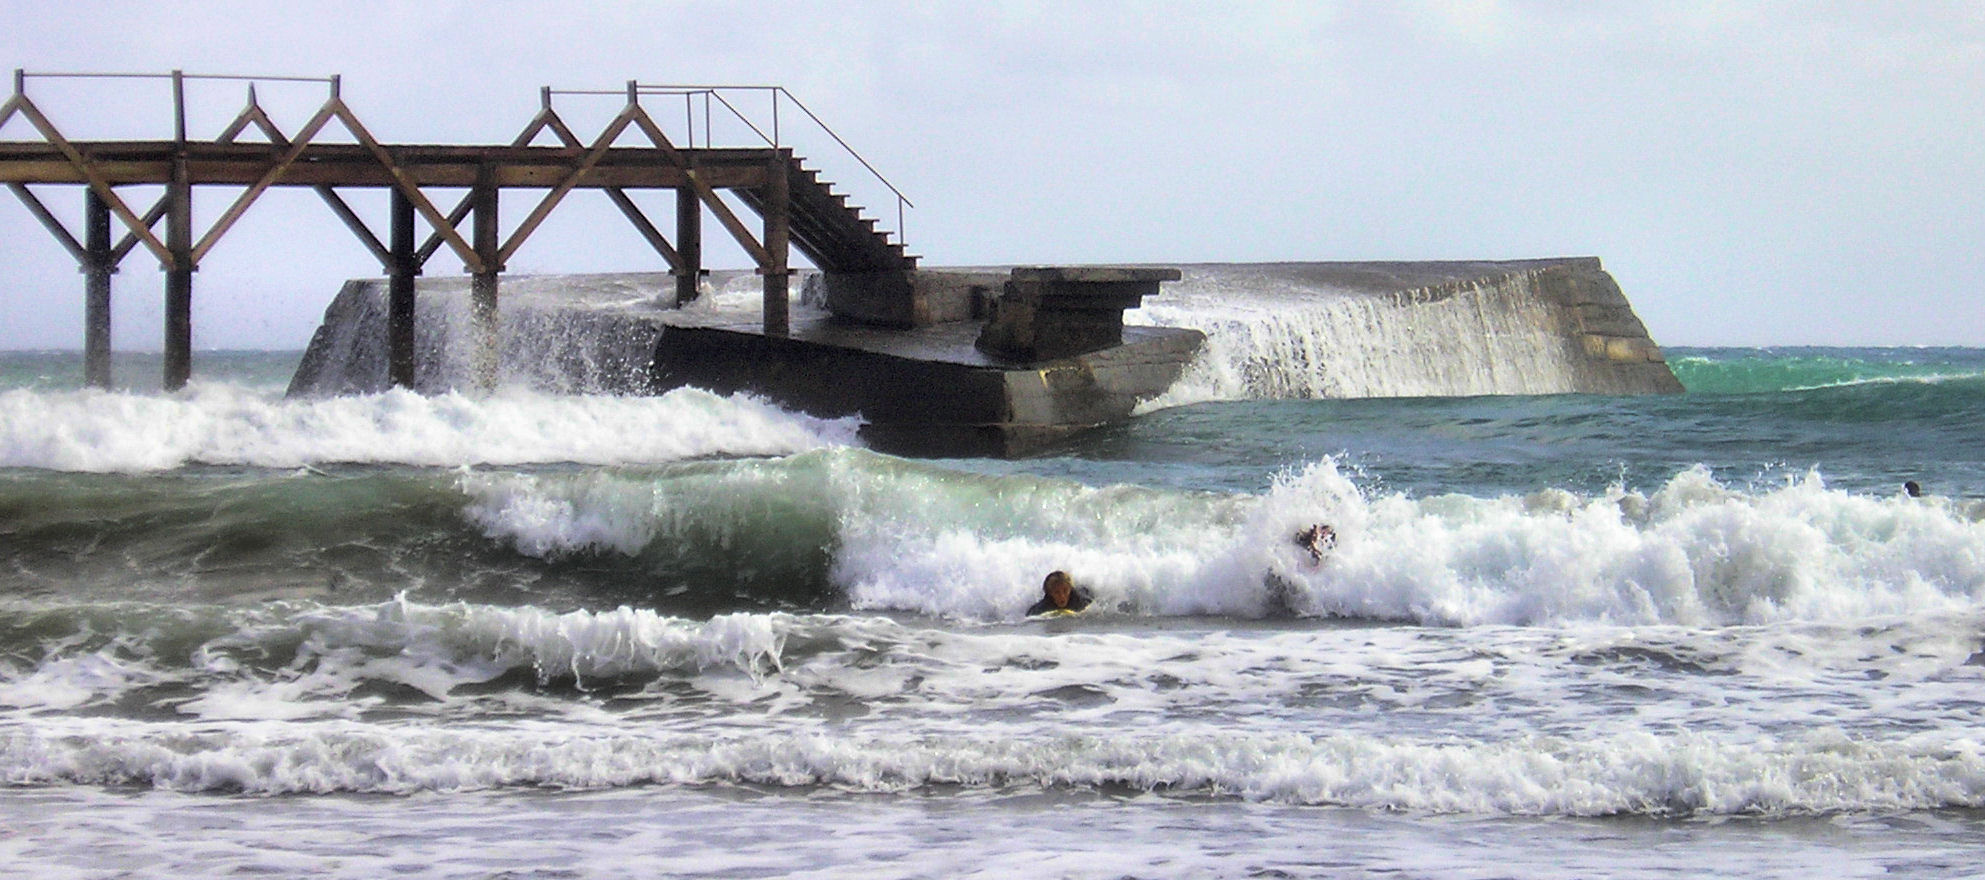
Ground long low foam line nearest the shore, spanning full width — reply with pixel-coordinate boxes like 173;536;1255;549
0;719;1985;816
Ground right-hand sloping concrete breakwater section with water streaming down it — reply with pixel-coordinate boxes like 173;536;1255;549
1127;258;1681;405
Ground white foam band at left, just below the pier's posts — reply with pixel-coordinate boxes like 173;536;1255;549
0;381;858;471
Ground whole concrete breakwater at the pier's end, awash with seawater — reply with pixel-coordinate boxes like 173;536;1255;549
290;258;1681;455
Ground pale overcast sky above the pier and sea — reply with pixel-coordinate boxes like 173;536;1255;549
0;0;1985;350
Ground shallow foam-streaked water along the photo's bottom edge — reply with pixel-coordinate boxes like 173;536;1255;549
0;787;1953;880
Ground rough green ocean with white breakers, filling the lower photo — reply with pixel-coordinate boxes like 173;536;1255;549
0;346;1985;880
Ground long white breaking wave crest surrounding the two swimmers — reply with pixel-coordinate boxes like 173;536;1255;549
450;451;1985;626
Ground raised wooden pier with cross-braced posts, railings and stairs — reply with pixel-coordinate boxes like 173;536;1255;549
0;70;917;389
